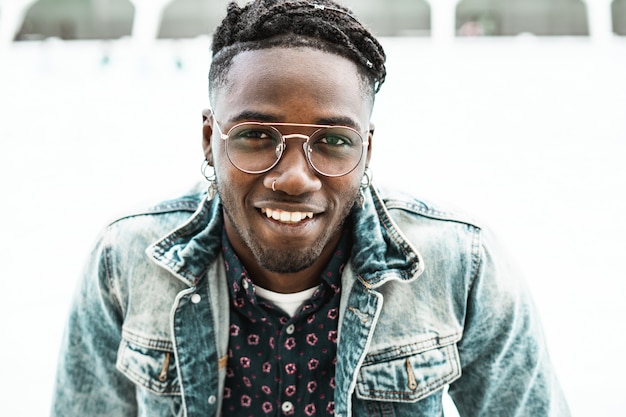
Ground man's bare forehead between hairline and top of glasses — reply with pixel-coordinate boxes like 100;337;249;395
212;47;372;123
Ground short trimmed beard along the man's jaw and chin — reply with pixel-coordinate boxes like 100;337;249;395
218;181;358;274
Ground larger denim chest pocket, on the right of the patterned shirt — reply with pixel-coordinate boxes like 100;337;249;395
356;343;461;403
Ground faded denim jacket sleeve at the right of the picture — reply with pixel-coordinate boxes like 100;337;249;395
449;231;570;417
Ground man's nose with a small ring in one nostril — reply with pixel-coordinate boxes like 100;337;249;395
265;139;322;195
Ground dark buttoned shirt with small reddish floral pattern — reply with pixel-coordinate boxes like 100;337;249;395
222;231;351;417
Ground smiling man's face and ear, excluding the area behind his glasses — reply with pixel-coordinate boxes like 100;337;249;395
203;48;371;274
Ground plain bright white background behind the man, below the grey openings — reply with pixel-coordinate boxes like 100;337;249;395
0;1;626;417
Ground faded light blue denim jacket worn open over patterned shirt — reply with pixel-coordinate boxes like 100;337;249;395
52;188;569;417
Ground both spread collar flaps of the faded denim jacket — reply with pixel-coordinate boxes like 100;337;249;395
146;187;423;289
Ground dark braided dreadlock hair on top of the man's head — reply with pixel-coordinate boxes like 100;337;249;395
209;0;386;100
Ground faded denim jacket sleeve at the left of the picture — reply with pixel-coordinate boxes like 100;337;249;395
51;228;137;417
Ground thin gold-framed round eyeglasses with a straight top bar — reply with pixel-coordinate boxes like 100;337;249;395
214;119;368;177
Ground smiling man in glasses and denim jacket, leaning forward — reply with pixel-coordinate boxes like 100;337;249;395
52;0;568;417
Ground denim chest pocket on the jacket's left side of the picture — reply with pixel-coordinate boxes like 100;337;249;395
116;332;181;395
